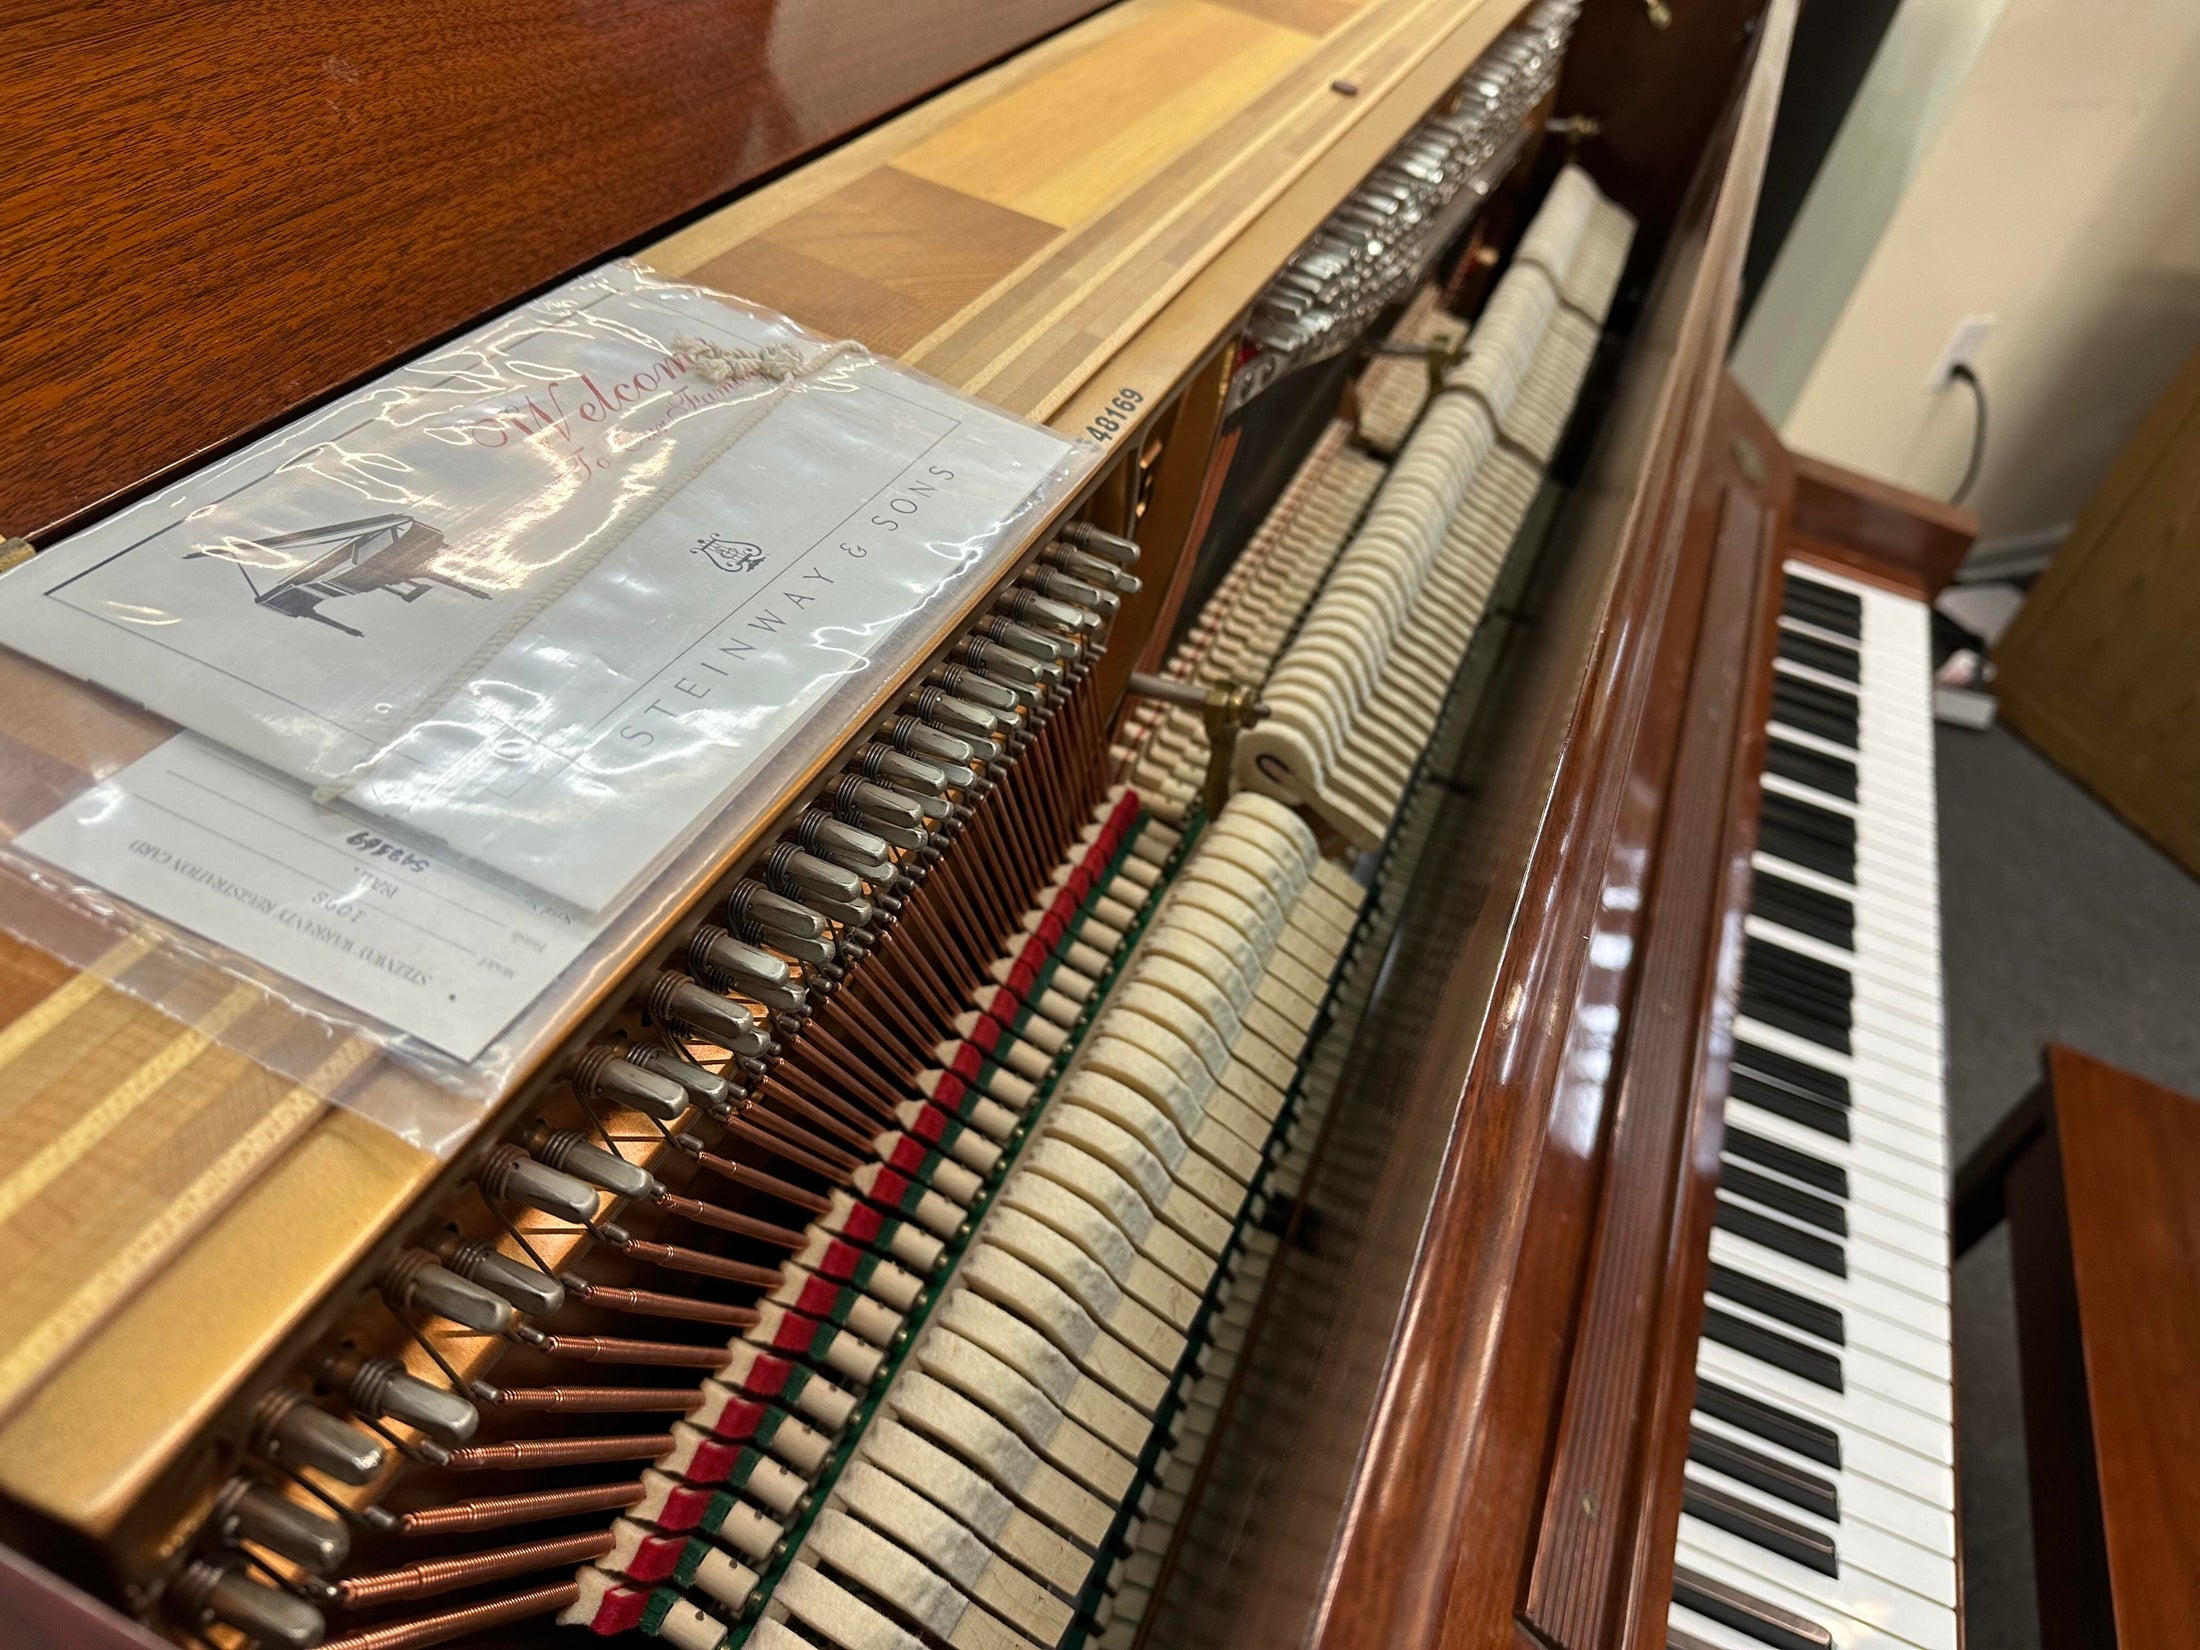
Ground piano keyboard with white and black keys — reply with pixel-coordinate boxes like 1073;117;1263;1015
1670;563;1958;1650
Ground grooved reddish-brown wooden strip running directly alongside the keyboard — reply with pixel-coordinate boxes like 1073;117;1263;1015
1527;385;1775;1650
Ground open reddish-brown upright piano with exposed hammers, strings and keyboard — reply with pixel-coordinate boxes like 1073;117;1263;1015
0;0;1973;1650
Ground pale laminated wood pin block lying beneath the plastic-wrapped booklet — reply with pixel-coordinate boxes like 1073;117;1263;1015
0;0;1516;1557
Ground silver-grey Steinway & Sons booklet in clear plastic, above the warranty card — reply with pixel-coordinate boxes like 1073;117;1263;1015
0;264;1085;919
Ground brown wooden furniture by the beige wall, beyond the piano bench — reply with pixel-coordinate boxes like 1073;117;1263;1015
1993;336;2200;876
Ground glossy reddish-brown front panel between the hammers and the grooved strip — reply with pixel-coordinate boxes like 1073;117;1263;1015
1148;4;1793;1650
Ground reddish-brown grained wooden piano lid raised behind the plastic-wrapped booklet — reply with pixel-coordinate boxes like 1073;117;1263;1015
0;0;1098;535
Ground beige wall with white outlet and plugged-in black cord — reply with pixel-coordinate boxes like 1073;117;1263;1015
1738;0;2200;539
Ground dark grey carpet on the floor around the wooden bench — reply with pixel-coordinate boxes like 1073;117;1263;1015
1938;728;2200;1650
